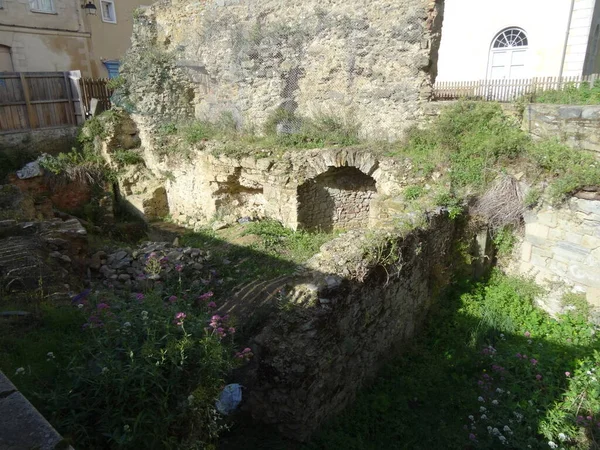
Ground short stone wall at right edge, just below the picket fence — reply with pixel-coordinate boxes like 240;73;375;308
523;103;600;153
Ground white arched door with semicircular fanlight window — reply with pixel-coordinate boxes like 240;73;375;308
488;27;529;80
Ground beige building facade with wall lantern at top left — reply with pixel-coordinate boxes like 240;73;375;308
0;0;143;77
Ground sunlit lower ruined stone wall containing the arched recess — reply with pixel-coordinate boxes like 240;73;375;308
120;139;418;229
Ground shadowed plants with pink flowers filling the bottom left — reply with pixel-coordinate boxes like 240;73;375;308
0;254;241;450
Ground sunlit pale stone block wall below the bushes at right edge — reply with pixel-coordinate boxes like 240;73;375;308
520;198;600;313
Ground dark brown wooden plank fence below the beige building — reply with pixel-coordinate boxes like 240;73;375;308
0;70;84;133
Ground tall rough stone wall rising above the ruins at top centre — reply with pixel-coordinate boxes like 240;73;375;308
126;0;443;139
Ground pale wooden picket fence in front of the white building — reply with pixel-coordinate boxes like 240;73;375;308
433;74;600;102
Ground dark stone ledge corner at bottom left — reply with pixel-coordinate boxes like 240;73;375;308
0;372;73;450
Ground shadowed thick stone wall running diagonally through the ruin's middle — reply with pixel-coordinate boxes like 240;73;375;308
234;214;478;439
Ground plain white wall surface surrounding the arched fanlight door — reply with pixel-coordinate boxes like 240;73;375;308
437;0;580;81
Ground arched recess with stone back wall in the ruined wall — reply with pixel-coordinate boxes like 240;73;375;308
298;166;377;231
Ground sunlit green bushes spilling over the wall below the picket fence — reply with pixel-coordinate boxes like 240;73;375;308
387;102;600;204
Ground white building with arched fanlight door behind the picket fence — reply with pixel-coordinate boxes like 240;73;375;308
437;0;600;81
